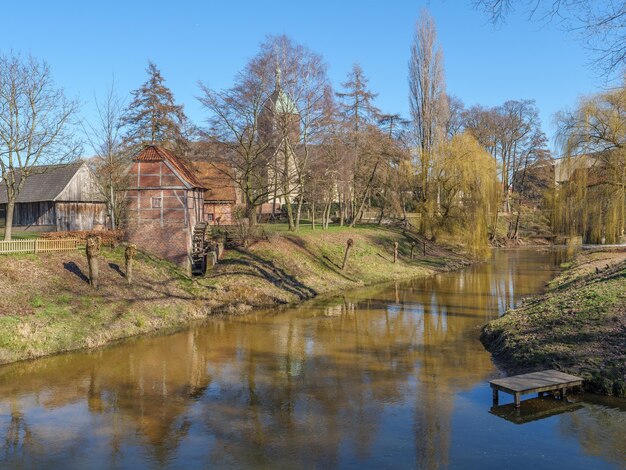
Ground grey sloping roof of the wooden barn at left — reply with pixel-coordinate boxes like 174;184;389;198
0;162;85;204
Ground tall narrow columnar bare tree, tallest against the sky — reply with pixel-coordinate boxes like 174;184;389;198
409;11;448;237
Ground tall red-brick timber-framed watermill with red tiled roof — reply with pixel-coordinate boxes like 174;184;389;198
124;145;205;269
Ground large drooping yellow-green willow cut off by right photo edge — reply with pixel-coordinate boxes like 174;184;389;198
553;80;626;243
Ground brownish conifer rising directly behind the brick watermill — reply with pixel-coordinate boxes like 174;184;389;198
123;62;188;156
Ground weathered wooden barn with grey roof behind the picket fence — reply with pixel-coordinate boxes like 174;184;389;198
0;162;107;231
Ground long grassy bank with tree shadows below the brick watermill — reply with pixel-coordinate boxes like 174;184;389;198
0;227;466;363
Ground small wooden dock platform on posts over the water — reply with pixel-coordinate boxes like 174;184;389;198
489;370;583;408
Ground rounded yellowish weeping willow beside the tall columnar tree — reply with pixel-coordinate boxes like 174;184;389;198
428;134;499;255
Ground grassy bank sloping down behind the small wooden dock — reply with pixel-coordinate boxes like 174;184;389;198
481;251;626;397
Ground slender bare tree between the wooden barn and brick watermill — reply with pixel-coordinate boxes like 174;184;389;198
86;82;128;230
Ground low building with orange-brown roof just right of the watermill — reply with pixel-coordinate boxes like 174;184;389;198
193;161;240;225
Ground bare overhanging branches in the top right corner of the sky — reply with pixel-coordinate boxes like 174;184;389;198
472;0;626;76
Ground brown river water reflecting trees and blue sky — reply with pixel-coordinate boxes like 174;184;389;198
0;250;626;468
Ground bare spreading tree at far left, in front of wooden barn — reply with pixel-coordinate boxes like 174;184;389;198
0;55;79;240
